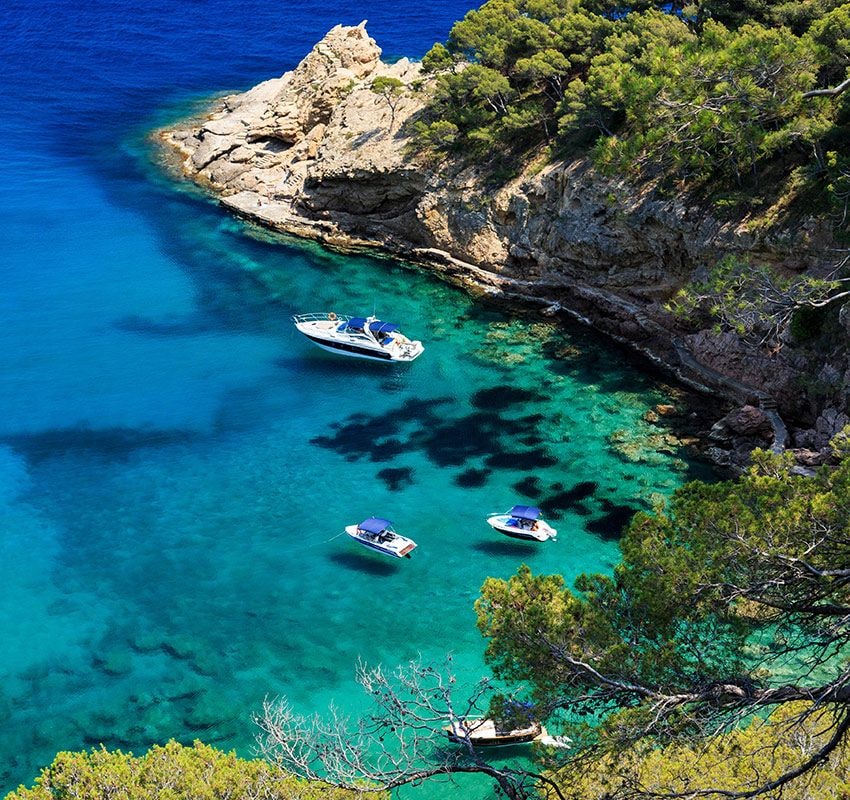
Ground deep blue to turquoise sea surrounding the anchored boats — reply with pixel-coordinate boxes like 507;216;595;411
0;0;708;798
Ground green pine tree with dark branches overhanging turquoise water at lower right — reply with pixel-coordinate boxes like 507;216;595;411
477;446;850;797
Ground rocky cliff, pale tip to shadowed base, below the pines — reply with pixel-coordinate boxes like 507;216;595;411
159;23;850;463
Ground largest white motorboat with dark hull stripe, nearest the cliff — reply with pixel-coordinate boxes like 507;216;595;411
292;311;425;362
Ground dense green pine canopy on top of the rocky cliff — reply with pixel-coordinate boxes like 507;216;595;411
418;0;850;206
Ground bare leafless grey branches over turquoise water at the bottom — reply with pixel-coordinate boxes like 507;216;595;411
254;659;564;800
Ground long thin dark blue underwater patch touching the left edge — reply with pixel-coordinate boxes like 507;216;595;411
0;427;203;465
